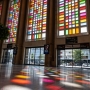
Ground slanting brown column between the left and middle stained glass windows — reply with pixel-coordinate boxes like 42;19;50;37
14;0;28;64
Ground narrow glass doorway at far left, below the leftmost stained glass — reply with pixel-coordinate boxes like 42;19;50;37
2;49;13;64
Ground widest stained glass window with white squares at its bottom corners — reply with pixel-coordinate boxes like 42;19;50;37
58;0;87;36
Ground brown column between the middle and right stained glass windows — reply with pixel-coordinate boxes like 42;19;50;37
45;0;56;66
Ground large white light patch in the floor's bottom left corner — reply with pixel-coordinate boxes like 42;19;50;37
0;85;31;90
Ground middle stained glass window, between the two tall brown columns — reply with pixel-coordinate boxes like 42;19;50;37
27;0;47;40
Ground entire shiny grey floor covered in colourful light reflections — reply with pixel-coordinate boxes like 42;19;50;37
0;65;90;90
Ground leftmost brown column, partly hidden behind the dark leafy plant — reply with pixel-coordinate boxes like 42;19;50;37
0;0;9;59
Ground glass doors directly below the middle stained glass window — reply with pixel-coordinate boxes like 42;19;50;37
24;47;45;65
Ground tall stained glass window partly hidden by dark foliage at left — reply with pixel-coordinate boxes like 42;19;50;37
6;0;20;43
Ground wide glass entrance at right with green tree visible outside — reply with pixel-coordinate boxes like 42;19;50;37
58;49;90;67
